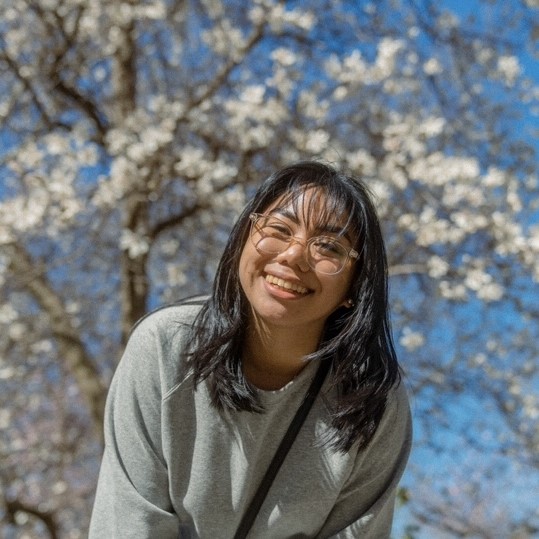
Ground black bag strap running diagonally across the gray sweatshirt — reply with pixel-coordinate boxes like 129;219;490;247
234;361;330;539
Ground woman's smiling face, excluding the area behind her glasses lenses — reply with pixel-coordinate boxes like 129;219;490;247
239;188;354;336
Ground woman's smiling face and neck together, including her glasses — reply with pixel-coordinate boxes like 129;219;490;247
239;187;356;389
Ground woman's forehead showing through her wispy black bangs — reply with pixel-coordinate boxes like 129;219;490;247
265;187;353;233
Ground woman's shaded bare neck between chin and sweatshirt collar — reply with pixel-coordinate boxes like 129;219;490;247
243;320;320;390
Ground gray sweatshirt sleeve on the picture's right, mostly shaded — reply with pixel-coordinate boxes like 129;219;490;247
319;383;412;539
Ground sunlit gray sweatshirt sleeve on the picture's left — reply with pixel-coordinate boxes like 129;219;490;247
89;315;179;539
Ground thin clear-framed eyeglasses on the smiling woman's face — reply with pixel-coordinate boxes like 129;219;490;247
249;213;359;275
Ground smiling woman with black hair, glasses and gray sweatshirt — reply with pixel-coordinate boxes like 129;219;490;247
90;162;411;539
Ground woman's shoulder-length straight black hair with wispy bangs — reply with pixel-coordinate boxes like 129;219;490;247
186;161;401;451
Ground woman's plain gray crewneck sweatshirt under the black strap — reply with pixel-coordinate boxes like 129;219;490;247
89;305;411;539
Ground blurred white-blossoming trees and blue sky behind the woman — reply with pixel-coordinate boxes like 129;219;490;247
0;0;539;539
